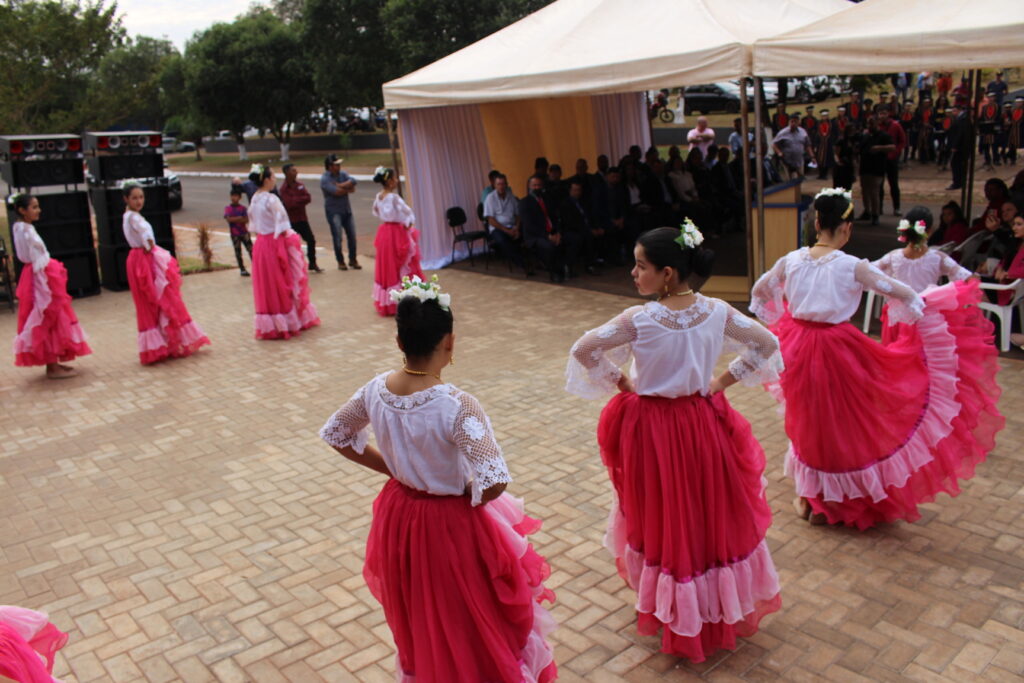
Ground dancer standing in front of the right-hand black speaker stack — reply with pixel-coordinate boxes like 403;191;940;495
122;182;210;366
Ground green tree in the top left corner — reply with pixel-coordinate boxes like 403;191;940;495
0;0;124;133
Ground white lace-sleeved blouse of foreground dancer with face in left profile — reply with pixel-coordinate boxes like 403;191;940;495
565;294;783;398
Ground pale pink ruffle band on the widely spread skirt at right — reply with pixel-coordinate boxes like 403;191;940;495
785;286;961;503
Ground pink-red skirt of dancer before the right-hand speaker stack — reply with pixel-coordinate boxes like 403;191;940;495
128;246;210;366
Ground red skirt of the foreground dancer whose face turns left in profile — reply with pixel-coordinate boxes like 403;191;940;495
597;393;781;661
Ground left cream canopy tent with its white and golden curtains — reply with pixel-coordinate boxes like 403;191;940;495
383;0;850;268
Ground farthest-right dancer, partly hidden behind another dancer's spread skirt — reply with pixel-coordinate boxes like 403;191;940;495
873;206;980;345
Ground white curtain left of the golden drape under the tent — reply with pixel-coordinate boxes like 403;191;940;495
401;104;490;270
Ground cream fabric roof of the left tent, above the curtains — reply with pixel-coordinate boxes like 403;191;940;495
384;0;850;110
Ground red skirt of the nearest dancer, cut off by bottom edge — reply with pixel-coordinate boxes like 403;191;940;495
362;479;557;683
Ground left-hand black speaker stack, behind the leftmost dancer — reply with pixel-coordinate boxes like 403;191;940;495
0;135;99;297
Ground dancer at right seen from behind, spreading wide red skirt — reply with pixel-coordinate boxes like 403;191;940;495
751;189;1004;529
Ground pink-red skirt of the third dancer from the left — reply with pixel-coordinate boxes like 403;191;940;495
252;232;319;339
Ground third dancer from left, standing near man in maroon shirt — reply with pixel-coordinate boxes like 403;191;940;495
249;164;319;339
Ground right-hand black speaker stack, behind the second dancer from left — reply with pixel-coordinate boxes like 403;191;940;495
83;130;174;290
